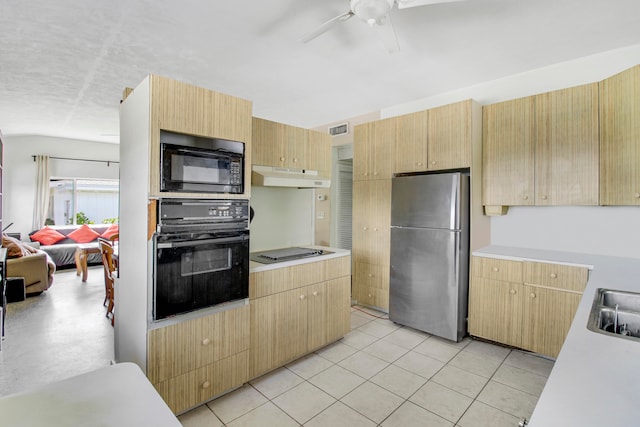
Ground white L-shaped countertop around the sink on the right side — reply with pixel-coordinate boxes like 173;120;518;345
473;246;640;427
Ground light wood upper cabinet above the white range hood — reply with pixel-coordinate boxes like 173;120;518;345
252;117;331;176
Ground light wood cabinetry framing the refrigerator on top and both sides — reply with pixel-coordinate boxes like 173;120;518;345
352;100;489;311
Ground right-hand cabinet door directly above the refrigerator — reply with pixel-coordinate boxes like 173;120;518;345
427;101;471;170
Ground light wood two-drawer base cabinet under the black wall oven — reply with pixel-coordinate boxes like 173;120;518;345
147;306;250;413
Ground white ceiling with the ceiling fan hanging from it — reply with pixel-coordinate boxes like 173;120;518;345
0;0;640;142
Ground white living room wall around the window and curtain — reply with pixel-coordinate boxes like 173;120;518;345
2;135;119;239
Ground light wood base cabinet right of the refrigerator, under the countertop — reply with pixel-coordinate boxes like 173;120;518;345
468;256;588;357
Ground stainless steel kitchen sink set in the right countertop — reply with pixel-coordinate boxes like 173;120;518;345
587;288;640;341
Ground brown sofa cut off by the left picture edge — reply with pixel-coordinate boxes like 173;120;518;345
2;234;56;295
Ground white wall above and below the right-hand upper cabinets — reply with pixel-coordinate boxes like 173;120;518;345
381;45;640;258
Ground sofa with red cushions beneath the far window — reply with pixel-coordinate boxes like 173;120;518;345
29;224;118;268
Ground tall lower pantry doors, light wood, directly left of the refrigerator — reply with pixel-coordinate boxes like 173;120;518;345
352;179;391;310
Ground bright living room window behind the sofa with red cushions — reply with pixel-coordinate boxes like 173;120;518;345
46;178;120;225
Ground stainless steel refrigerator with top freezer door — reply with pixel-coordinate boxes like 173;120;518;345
389;172;469;341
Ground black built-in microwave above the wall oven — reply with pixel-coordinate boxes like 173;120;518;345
160;130;244;194
